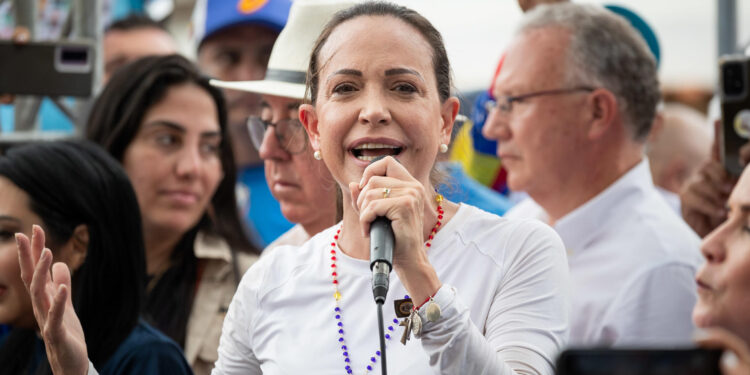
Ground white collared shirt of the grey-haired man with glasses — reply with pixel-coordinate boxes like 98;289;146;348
506;158;703;346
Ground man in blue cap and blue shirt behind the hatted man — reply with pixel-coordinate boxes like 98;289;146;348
192;0;292;247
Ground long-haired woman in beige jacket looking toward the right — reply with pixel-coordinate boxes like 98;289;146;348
86;55;257;374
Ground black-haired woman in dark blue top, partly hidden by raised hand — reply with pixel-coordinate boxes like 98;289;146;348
0;142;190;374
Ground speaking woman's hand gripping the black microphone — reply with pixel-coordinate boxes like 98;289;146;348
349;157;440;303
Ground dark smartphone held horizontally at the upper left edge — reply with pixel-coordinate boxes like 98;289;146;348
0;40;94;97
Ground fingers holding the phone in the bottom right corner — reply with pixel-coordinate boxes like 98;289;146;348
695;328;750;375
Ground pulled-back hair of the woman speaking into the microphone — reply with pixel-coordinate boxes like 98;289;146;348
306;1;451;104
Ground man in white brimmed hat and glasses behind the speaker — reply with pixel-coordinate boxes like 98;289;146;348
211;0;354;249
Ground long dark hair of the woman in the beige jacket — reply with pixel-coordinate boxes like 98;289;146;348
86;55;259;346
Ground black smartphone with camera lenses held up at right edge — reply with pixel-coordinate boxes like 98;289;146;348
718;55;750;176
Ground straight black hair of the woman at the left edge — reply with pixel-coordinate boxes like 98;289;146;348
0;141;146;373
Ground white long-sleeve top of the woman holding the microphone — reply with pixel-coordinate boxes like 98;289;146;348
213;205;569;375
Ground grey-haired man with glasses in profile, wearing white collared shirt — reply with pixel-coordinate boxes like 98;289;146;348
483;4;702;346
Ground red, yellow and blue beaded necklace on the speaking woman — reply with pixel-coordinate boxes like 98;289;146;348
331;194;444;374
